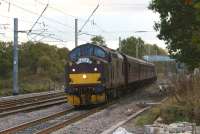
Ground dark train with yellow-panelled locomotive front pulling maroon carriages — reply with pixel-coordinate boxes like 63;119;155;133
65;43;157;107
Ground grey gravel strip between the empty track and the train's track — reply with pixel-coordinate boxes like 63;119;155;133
0;104;70;130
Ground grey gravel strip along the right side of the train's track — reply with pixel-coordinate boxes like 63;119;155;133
53;81;163;134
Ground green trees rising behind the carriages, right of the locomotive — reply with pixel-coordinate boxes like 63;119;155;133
121;36;167;58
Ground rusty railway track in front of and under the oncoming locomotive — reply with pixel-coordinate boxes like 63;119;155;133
0;103;114;134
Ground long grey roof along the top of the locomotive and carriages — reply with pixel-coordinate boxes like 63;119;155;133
80;43;154;66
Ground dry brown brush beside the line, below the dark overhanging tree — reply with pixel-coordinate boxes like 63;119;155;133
161;75;200;124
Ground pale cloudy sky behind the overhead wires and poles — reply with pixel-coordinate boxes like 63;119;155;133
0;0;165;50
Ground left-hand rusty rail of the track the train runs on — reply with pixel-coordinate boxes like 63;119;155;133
0;107;74;134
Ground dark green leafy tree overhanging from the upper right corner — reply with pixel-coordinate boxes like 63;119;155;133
149;0;200;69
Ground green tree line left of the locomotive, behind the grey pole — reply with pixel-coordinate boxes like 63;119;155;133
0;42;69;79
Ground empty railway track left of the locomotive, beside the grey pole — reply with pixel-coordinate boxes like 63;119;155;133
0;92;66;117
